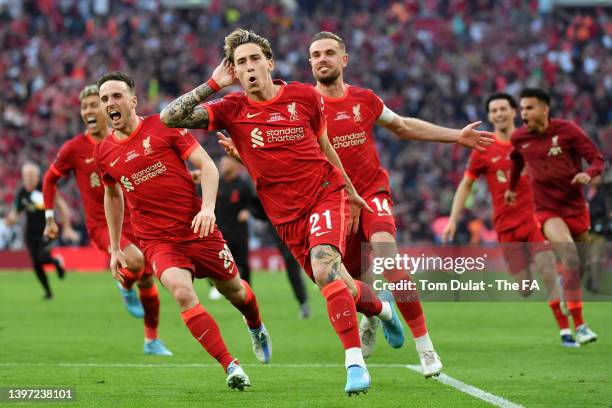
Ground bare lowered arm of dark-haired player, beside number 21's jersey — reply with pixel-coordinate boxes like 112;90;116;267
187;146;219;238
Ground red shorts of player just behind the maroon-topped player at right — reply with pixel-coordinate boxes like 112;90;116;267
498;221;551;275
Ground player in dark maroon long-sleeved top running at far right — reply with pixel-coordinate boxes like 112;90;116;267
505;88;604;344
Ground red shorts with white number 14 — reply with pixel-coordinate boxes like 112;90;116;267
343;191;396;280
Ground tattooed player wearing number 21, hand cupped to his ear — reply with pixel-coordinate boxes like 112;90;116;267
161;29;403;395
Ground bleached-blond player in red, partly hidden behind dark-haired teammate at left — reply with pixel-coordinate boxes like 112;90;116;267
43;85;172;355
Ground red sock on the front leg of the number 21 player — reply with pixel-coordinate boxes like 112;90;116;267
321;280;361;350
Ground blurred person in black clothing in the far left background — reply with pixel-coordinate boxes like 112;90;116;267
5;162;75;300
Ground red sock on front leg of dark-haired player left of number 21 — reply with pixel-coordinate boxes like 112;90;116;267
181;303;234;371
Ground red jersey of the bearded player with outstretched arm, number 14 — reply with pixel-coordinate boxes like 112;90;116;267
323;85;390;197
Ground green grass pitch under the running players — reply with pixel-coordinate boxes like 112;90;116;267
0;272;612;407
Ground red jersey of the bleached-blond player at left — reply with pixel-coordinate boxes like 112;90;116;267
50;133;132;234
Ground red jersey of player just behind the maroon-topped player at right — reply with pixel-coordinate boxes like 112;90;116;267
465;139;534;233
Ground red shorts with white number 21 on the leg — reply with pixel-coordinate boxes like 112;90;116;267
275;188;349;281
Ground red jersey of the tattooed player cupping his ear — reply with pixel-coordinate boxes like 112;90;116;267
203;80;344;225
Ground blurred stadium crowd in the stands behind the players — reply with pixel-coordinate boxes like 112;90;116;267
0;0;612;247
